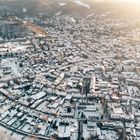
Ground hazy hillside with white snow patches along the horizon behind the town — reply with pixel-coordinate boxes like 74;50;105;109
0;0;140;16
